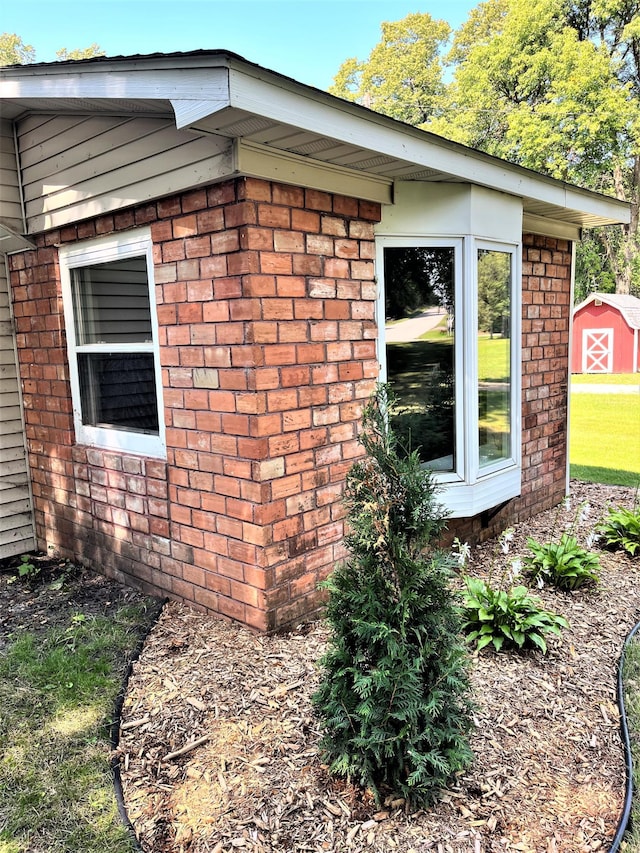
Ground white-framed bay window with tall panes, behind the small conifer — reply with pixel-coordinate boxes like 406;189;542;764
378;237;521;516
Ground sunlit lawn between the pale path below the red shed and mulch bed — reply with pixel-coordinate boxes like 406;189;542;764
569;394;640;487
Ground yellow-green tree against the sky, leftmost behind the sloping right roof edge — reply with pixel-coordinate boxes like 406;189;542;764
329;13;451;125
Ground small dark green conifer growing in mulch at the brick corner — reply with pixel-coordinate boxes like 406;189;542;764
313;385;472;806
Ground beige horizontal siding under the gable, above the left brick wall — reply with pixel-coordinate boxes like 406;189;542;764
18;115;233;234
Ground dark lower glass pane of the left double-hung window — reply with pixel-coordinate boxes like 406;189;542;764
78;353;158;435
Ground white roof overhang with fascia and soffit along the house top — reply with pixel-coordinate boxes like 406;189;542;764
0;51;630;239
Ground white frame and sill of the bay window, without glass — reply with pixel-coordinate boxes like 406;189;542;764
376;234;522;518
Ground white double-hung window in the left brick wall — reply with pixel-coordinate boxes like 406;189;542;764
60;225;164;456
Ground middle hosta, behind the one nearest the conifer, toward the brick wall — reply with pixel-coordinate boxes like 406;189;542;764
524;533;600;590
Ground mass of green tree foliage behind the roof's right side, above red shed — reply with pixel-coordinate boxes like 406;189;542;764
337;0;640;293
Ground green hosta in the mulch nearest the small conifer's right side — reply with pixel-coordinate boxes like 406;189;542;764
461;575;568;654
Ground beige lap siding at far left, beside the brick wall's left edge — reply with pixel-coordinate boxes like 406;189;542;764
0;255;36;558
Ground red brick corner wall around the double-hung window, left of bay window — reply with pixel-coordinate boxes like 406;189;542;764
11;179;380;630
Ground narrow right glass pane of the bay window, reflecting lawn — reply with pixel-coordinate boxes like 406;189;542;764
478;249;511;467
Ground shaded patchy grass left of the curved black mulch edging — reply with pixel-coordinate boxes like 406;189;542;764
0;572;159;853
